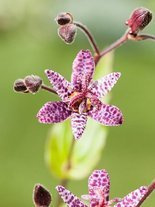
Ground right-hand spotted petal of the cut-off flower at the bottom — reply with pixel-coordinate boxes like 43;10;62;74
114;186;147;207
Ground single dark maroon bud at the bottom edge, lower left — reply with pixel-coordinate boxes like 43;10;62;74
33;184;52;207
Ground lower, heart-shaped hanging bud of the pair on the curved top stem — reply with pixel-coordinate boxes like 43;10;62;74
58;24;77;44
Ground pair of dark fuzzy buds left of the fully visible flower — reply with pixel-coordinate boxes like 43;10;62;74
13;75;42;94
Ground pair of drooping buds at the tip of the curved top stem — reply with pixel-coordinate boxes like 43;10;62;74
55;12;77;44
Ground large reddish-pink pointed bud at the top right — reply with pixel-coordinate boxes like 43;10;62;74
126;8;152;35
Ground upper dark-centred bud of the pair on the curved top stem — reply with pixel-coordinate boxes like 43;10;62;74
55;12;73;25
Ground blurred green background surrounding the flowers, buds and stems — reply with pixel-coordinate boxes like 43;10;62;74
0;0;155;207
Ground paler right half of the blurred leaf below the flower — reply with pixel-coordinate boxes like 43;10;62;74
69;119;107;179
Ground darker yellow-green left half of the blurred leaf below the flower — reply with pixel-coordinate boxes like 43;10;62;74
45;121;72;179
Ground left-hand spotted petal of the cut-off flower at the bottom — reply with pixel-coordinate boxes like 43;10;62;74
56;185;87;207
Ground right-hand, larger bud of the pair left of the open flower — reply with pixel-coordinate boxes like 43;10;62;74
24;75;42;93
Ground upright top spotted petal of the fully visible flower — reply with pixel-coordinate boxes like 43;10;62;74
71;50;95;91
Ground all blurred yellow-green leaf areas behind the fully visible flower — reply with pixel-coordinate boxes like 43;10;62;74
45;54;113;179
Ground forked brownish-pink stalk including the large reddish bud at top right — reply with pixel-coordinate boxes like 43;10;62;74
65;8;155;65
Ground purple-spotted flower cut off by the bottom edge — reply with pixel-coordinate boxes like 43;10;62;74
56;170;147;207
